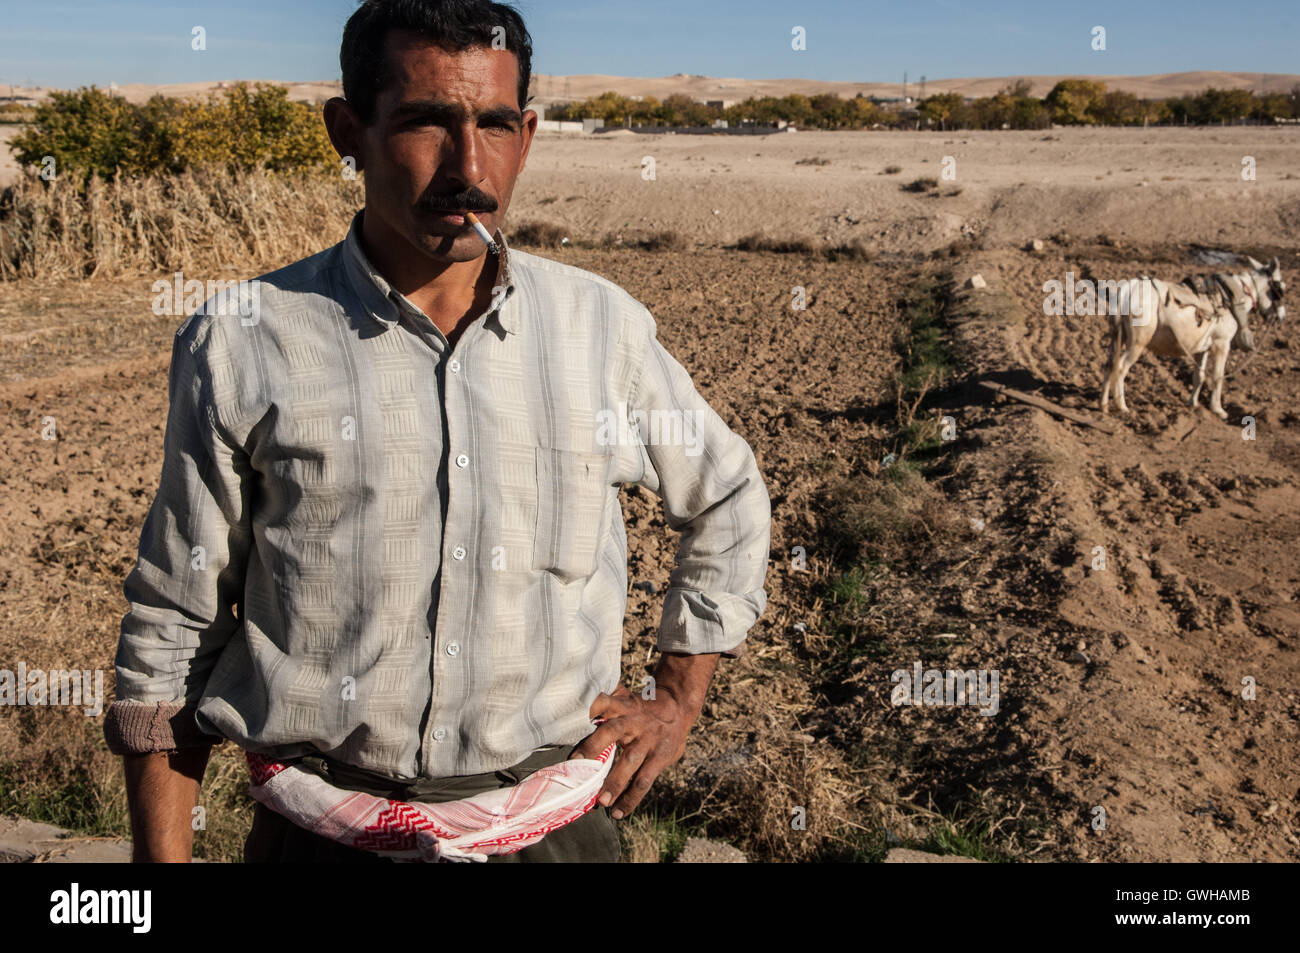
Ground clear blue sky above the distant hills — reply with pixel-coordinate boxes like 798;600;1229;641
0;0;1300;86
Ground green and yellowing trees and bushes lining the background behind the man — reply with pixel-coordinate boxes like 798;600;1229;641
10;79;1300;178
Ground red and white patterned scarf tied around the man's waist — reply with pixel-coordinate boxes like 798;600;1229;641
246;744;616;862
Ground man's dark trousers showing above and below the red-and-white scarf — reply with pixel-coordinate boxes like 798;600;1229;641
244;746;621;863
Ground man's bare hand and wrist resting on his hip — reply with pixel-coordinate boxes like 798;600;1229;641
572;653;719;819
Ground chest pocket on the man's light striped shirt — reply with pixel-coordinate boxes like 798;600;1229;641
533;447;614;582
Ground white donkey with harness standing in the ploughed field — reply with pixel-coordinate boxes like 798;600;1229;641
1101;256;1287;420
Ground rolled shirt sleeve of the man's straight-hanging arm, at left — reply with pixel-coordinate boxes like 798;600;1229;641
104;321;251;754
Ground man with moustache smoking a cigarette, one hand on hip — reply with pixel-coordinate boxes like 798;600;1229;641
105;0;770;861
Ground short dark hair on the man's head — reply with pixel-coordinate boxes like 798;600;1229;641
338;0;533;122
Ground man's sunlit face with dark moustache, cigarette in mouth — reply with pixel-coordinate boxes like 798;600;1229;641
332;30;537;263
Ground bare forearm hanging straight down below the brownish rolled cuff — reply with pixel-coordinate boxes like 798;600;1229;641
122;746;212;863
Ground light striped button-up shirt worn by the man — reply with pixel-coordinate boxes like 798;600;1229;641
105;215;771;779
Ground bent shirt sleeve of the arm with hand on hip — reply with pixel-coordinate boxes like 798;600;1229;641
629;312;772;658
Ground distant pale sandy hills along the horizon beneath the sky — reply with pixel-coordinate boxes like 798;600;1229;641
0;70;1300;104
